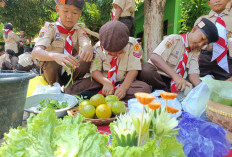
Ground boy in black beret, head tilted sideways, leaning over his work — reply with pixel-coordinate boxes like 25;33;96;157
139;18;218;92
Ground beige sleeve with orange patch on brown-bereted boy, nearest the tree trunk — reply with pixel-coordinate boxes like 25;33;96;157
127;44;143;71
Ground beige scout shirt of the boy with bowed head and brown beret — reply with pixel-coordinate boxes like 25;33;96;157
90;37;142;82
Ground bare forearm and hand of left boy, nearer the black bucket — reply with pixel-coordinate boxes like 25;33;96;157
31;46;79;70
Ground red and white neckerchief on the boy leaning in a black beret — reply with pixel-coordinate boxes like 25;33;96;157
171;34;191;92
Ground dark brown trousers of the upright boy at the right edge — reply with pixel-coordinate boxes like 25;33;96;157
199;53;232;80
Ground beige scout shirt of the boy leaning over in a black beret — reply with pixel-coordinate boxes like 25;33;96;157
148;34;200;77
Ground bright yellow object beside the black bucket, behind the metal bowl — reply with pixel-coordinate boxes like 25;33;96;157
27;76;48;97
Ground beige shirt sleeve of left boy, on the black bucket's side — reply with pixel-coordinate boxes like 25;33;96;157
35;23;55;48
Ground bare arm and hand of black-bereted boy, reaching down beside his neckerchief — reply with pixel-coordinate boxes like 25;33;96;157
151;53;192;91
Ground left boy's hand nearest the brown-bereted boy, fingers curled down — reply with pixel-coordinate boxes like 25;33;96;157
80;45;93;62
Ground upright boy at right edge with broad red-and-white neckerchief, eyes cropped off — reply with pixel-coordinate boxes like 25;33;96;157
196;0;232;80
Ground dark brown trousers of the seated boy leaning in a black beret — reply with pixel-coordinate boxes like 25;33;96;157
138;62;170;91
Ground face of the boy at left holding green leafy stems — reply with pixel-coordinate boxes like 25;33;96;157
56;5;81;30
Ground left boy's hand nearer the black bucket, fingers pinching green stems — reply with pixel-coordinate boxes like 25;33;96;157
53;53;80;70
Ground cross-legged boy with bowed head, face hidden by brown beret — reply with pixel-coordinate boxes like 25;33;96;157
67;21;151;101
